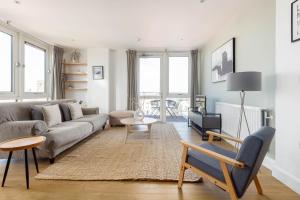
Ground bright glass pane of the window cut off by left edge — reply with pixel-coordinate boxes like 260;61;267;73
0;31;13;92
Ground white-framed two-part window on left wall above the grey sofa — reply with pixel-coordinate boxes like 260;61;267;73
0;25;51;101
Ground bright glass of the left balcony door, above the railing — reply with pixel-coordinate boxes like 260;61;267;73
139;57;160;95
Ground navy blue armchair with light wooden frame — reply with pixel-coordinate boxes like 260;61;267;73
178;127;275;200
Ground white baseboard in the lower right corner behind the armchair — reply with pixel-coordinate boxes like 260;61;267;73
272;165;300;194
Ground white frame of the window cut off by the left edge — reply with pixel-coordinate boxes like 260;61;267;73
0;26;18;99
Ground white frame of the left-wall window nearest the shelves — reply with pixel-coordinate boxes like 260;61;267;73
19;34;50;100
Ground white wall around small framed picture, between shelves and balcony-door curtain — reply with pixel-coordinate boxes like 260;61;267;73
64;48;127;113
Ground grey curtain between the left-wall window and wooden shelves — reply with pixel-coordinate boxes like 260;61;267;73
51;46;65;99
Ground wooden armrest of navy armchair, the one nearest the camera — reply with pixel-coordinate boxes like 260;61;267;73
181;140;245;168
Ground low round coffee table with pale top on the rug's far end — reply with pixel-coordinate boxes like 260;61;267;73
120;117;158;143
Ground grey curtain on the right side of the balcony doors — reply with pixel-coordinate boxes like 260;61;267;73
191;50;199;107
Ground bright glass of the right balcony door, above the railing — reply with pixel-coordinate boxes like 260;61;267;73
169;57;189;94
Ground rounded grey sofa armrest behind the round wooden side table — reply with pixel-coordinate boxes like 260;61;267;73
0;120;48;142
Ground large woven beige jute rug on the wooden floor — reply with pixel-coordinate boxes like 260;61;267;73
35;123;199;182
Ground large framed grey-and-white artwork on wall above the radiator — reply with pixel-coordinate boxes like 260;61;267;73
211;38;235;83
